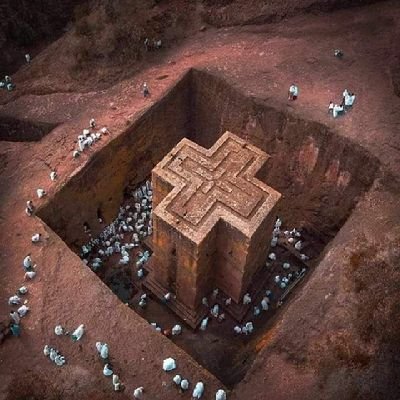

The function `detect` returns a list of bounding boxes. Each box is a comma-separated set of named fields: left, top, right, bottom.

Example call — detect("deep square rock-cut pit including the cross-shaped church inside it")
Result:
left=37, top=70, right=378, bottom=387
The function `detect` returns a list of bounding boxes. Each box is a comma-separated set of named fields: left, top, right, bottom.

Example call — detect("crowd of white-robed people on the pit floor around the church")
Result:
left=76, top=180, right=308, bottom=344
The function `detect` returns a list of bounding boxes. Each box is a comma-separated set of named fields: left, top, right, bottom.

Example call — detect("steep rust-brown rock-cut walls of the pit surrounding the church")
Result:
left=38, top=70, right=379, bottom=387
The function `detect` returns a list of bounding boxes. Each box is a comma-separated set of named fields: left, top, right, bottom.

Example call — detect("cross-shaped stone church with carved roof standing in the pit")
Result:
left=151, top=132, right=281, bottom=316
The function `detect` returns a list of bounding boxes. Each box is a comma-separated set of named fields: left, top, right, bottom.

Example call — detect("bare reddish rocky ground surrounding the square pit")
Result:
left=0, top=1, right=400, bottom=400
